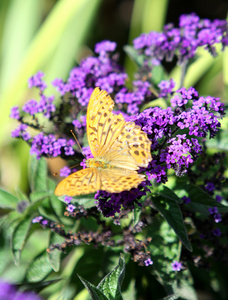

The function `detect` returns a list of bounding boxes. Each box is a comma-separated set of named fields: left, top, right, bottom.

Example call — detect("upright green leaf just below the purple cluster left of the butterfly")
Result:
left=29, top=155, right=47, bottom=191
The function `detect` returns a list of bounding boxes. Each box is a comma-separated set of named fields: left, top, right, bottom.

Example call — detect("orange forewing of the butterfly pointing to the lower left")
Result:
left=55, top=168, right=101, bottom=196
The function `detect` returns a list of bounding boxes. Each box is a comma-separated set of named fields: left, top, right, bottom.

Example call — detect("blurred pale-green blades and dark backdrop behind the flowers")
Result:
left=0, top=0, right=228, bottom=197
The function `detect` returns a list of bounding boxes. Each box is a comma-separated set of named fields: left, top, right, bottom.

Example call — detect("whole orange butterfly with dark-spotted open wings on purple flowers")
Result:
left=55, top=88, right=152, bottom=196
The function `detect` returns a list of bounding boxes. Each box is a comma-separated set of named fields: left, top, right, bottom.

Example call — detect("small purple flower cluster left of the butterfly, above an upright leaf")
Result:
left=30, top=132, right=75, bottom=159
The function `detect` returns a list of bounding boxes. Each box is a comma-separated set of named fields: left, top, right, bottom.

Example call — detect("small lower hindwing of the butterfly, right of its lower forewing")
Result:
left=99, top=169, right=145, bottom=193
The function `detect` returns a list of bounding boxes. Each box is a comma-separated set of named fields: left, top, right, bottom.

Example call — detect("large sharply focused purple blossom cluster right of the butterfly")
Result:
left=130, top=88, right=225, bottom=182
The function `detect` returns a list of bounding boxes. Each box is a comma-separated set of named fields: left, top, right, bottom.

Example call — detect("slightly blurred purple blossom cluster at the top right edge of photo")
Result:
left=133, top=14, right=228, bottom=65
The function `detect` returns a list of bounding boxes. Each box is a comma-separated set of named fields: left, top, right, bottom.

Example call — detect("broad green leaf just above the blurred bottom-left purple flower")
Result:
left=26, top=250, right=53, bottom=282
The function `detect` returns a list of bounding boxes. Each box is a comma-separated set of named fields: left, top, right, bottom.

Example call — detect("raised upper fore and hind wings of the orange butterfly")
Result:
left=87, top=88, right=152, bottom=170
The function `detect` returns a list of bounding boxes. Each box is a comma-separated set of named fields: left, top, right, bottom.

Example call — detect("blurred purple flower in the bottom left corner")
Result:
left=0, top=280, right=41, bottom=300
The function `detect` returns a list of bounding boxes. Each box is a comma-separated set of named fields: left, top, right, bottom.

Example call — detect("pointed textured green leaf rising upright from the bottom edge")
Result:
left=98, top=257, right=125, bottom=300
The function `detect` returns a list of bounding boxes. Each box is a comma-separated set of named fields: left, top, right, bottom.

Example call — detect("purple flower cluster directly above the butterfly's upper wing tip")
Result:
left=52, top=41, right=127, bottom=106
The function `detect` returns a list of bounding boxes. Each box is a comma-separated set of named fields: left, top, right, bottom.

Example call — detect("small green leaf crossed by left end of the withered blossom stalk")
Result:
left=47, top=232, right=64, bottom=272
